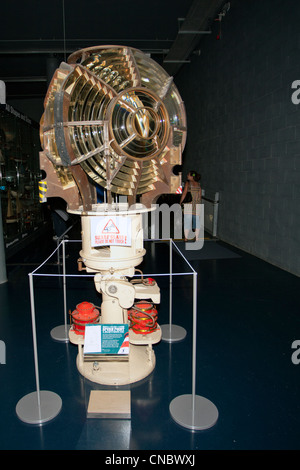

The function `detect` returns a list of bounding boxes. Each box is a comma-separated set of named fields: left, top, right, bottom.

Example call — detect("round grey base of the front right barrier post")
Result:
left=169, top=395, right=219, bottom=430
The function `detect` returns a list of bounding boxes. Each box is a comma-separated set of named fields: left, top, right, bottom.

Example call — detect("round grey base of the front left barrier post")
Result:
left=16, top=390, right=62, bottom=424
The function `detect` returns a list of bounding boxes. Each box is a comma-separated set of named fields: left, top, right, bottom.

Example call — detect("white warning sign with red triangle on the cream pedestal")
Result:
left=91, top=215, right=131, bottom=247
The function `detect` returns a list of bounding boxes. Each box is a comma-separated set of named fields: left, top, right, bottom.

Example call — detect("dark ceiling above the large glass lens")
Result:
left=0, top=0, right=225, bottom=100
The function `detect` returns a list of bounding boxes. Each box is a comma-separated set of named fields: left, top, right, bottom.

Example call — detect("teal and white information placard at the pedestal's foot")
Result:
left=83, top=323, right=129, bottom=356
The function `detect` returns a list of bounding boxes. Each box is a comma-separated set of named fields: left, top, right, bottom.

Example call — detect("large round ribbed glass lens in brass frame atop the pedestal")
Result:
left=40, top=46, right=186, bottom=207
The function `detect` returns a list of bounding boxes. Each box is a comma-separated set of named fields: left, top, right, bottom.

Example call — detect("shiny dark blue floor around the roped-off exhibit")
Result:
left=0, top=229, right=300, bottom=451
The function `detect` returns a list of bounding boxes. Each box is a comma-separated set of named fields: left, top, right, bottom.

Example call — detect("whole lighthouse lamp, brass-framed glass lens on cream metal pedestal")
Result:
left=40, top=46, right=186, bottom=385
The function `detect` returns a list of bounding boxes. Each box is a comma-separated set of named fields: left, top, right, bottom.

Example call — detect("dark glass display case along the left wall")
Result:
left=0, top=104, right=44, bottom=252
